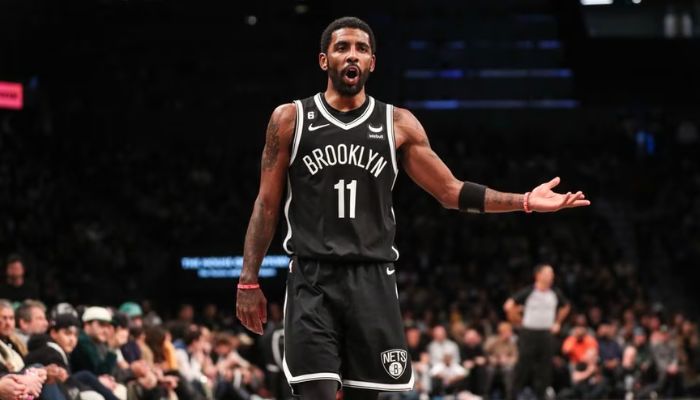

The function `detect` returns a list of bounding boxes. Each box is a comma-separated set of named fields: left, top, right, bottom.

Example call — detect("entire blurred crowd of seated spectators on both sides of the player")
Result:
left=0, top=256, right=700, bottom=400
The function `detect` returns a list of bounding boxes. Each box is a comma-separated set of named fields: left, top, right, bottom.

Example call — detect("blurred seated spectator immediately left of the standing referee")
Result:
left=484, top=322, right=518, bottom=398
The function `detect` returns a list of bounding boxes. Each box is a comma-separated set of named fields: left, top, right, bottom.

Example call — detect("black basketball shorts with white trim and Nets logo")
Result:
left=283, top=257, right=413, bottom=392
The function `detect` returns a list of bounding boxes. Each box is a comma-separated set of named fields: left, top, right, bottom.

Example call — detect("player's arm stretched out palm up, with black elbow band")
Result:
left=394, top=107, right=590, bottom=213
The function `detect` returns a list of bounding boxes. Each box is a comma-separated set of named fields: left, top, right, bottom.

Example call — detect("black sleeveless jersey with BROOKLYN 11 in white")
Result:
left=283, top=93, right=399, bottom=261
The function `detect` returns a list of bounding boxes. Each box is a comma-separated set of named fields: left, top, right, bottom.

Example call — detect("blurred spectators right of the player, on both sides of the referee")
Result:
left=406, top=296, right=700, bottom=399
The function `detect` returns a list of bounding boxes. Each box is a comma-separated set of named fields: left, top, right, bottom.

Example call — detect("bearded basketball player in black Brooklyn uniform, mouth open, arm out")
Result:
left=236, top=17, right=589, bottom=400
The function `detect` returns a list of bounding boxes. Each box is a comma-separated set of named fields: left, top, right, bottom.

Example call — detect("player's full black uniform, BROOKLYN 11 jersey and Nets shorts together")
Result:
left=283, top=93, right=413, bottom=391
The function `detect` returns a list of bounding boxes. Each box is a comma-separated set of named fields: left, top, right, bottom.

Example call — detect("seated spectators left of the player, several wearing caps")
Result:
left=0, top=257, right=288, bottom=400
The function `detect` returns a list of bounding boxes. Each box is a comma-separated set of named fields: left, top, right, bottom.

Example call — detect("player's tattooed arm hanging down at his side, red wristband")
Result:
left=236, top=104, right=296, bottom=335
